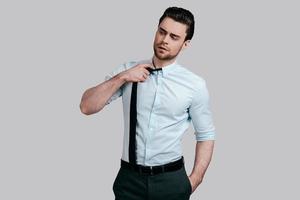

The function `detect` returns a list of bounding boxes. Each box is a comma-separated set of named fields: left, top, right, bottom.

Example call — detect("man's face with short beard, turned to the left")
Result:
left=153, top=17, right=190, bottom=61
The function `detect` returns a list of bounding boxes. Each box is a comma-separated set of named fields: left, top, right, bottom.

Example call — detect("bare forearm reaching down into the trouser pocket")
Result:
left=189, top=140, right=214, bottom=192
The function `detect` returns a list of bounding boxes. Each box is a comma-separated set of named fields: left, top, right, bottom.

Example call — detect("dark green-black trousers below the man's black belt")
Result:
left=113, top=162, right=192, bottom=200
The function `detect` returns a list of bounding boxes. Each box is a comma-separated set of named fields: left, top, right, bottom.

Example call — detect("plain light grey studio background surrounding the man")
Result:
left=0, top=0, right=300, bottom=200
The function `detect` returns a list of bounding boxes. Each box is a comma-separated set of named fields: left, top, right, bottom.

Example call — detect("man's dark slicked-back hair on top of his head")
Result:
left=159, top=7, right=195, bottom=41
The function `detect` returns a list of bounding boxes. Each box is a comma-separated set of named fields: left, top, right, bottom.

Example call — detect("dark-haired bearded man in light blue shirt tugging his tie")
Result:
left=80, top=7, right=215, bottom=200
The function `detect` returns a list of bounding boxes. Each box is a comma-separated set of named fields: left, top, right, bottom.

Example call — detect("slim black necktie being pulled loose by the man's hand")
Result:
left=129, top=67, right=162, bottom=165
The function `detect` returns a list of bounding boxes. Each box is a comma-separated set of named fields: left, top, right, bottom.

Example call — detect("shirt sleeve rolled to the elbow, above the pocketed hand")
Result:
left=189, top=80, right=215, bottom=141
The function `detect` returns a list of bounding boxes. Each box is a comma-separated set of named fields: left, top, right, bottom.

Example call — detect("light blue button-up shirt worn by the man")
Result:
left=105, top=59, right=215, bottom=166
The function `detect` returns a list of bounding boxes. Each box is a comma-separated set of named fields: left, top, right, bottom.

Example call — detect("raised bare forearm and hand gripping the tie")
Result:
left=80, top=64, right=151, bottom=115
